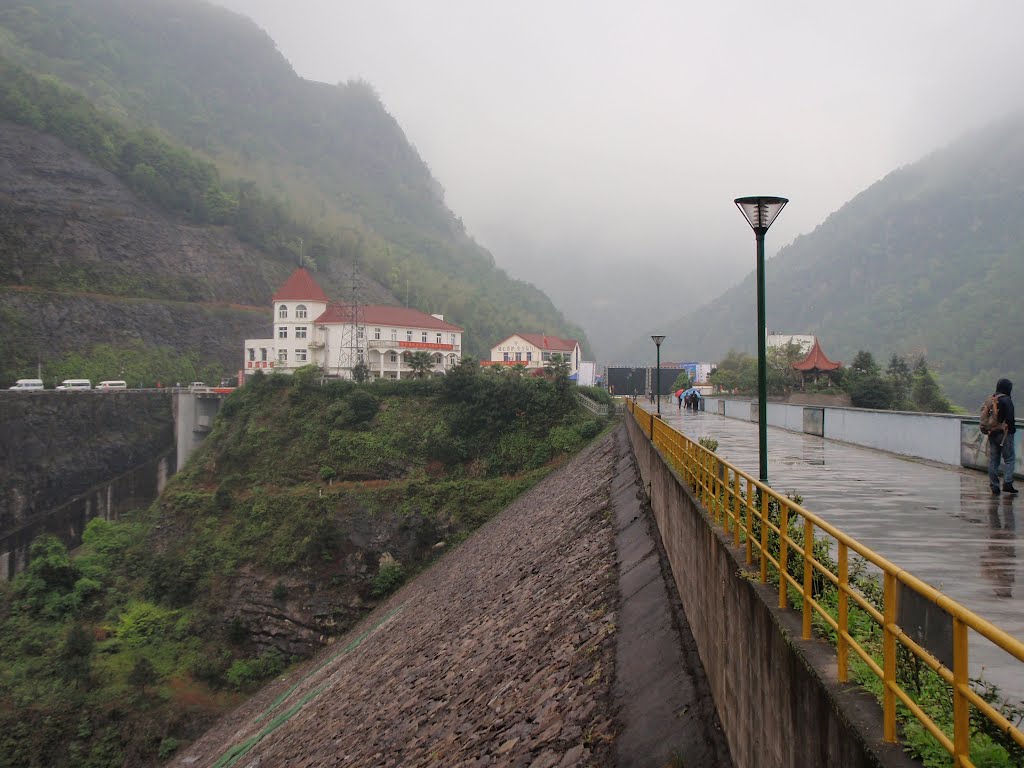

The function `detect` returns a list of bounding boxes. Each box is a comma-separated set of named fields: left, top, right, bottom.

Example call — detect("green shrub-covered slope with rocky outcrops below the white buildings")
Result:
left=0, top=366, right=602, bottom=766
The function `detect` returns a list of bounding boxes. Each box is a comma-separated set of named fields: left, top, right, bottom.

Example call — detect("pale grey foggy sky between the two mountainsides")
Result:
left=209, top=0, right=1024, bottom=360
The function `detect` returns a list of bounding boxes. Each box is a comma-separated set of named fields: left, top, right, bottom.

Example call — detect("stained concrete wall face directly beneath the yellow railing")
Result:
left=626, top=417, right=918, bottom=768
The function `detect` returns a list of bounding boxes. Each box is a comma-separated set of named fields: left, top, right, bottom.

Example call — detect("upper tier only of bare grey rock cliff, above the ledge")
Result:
left=0, top=122, right=294, bottom=306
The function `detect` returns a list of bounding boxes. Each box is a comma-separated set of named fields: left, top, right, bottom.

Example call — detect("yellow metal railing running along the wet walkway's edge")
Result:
left=627, top=401, right=1024, bottom=768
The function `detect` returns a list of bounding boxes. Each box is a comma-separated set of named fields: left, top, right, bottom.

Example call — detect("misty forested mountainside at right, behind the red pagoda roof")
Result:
left=662, top=114, right=1024, bottom=411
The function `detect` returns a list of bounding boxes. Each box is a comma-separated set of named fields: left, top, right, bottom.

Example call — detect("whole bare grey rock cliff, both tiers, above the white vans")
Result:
left=0, top=121, right=294, bottom=378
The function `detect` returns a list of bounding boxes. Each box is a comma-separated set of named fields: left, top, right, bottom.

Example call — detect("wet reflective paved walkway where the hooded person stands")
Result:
left=638, top=399, right=1024, bottom=700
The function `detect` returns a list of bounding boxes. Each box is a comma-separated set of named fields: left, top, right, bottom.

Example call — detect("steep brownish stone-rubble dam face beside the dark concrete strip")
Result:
left=174, top=438, right=617, bottom=768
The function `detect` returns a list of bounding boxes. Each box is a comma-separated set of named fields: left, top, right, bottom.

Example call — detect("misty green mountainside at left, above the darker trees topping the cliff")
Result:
left=0, top=0, right=583, bottom=356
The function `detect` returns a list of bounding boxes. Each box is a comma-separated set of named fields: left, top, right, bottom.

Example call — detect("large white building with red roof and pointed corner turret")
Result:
left=242, top=267, right=463, bottom=379
